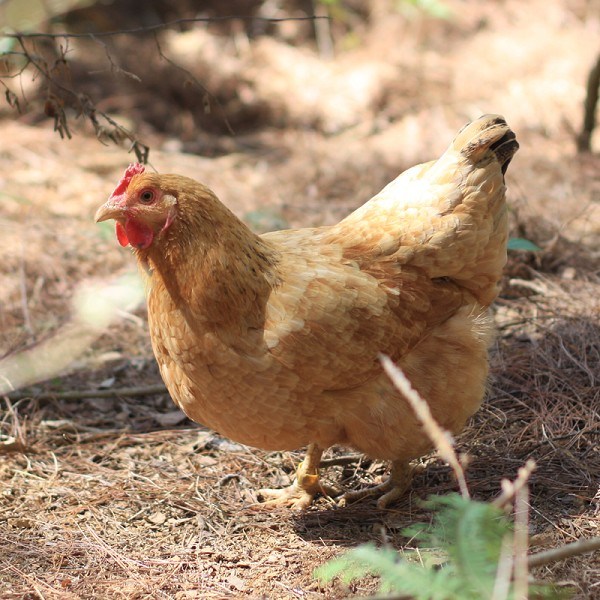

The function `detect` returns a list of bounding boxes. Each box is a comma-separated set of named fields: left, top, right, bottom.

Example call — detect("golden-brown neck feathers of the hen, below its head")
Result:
left=137, top=182, right=279, bottom=336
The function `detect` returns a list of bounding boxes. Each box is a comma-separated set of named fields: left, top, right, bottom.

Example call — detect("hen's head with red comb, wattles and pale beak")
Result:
left=96, top=163, right=218, bottom=250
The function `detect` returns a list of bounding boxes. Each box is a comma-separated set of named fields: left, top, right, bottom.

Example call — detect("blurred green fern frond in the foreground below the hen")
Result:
left=314, top=494, right=558, bottom=600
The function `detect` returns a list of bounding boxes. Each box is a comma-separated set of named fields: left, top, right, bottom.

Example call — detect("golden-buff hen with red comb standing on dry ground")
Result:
left=96, top=115, right=518, bottom=508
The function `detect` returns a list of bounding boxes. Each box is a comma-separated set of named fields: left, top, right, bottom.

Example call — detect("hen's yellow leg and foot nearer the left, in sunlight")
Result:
left=258, top=444, right=339, bottom=510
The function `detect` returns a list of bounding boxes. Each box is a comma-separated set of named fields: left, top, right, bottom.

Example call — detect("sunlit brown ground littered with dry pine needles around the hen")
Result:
left=0, top=0, right=600, bottom=600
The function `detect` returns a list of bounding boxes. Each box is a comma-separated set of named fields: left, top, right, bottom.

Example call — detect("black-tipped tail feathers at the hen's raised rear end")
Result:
left=451, top=115, right=519, bottom=174
